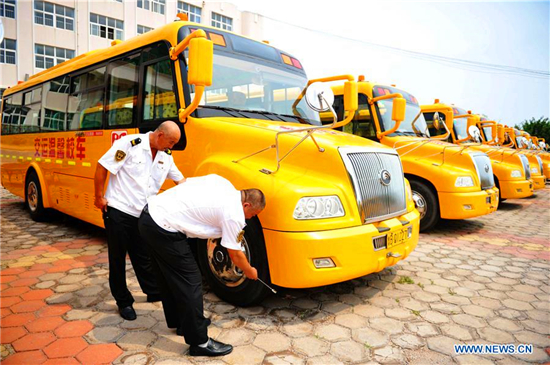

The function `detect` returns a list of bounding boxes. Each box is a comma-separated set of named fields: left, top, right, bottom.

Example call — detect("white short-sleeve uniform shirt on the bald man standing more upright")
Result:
left=99, top=132, right=183, bottom=217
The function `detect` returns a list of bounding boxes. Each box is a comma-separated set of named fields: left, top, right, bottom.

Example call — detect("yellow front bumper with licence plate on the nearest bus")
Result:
left=264, top=209, right=419, bottom=288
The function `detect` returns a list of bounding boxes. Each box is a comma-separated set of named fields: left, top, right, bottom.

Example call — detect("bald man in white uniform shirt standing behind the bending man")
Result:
left=94, top=121, right=185, bottom=321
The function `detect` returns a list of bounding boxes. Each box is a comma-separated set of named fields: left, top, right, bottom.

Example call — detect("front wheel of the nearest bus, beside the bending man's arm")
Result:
left=197, top=218, right=270, bottom=307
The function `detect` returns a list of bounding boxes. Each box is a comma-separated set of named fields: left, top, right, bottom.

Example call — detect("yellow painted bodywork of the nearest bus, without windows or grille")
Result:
left=0, top=21, right=419, bottom=287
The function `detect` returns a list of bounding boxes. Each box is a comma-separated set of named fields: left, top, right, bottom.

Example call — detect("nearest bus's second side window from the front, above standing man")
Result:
left=106, top=54, right=140, bottom=127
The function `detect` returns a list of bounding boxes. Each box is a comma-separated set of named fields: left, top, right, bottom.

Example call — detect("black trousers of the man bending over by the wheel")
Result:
left=139, top=206, right=208, bottom=346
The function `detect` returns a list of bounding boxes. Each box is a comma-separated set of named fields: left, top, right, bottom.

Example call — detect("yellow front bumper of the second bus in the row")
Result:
left=438, top=187, right=498, bottom=219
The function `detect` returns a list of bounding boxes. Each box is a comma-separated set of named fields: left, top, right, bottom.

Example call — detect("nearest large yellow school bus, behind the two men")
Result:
left=0, top=17, right=419, bottom=305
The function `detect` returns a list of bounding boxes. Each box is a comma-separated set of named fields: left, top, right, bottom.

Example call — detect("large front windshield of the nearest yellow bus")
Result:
left=185, top=27, right=321, bottom=125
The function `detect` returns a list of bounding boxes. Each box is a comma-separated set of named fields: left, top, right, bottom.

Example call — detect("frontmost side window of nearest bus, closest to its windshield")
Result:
left=143, top=59, right=178, bottom=121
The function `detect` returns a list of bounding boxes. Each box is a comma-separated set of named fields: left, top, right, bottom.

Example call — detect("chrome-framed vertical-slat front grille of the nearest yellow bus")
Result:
left=339, top=147, right=407, bottom=224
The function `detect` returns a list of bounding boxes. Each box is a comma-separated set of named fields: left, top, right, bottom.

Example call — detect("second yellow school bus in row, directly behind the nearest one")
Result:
left=333, top=82, right=498, bottom=231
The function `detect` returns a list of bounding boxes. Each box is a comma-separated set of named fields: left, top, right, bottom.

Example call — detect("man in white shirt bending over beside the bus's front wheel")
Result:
left=139, top=175, right=265, bottom=356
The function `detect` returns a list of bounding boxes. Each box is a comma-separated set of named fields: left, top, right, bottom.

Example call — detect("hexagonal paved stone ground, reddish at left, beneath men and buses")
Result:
left=0, top=187, right=550, bottom=365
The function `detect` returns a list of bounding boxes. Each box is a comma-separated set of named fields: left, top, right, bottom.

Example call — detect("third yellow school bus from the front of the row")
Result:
left=422, top=99, right=533, bottom=201
